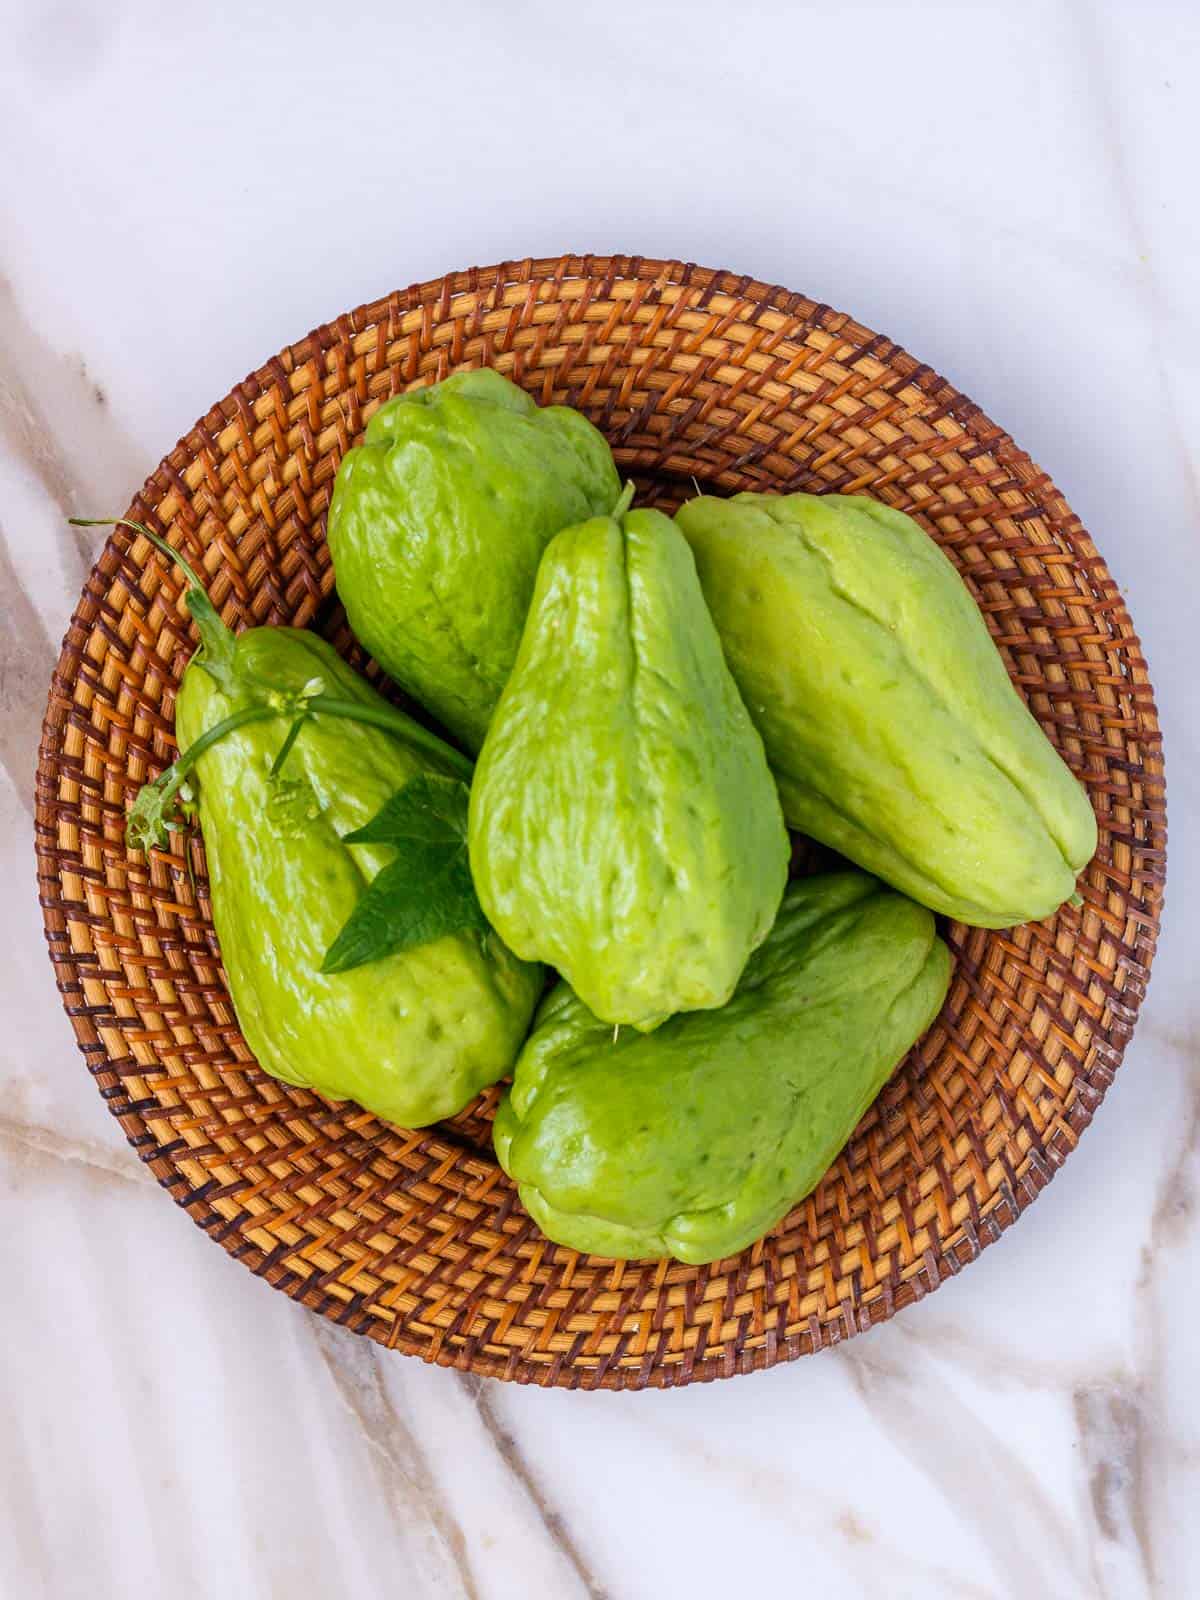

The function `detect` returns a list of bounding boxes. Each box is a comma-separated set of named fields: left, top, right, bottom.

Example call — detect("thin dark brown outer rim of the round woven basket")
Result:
left=34, top=254, right=1166, bottom=1392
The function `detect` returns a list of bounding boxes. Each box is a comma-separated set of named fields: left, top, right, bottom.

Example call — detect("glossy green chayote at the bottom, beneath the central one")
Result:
left=494, top=872, right=950, bottom=1264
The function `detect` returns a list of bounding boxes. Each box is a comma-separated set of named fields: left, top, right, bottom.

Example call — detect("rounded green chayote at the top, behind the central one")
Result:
left=328, top=368, right=621, bottom=750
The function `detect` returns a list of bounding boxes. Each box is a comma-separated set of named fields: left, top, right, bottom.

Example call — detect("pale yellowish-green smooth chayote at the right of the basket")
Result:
left=675, top=494, right=1096, bottom=928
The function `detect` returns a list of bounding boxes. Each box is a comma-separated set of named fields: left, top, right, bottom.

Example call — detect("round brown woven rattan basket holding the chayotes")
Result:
left=37, top=256, right=1165, bottom=1389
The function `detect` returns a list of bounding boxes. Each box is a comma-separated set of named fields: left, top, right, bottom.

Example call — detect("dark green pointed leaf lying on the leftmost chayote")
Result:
left=322, top=776, right=488, bottom=973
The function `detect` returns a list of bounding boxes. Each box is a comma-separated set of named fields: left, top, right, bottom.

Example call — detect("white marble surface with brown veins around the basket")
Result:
left=0, top=0, right=1200, bottom=1600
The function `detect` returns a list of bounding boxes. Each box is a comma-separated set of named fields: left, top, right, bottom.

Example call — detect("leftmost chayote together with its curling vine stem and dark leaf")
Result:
left=102, top=523, right=541, bottom=1126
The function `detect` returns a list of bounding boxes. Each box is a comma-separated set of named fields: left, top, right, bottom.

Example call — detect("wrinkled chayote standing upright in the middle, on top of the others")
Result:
left=469, top=491, right=789, bottom=1029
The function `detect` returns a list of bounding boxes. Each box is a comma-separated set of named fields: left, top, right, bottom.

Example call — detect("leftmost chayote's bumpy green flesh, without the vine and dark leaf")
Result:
left=176, top=624, right=541, bottom=1126
